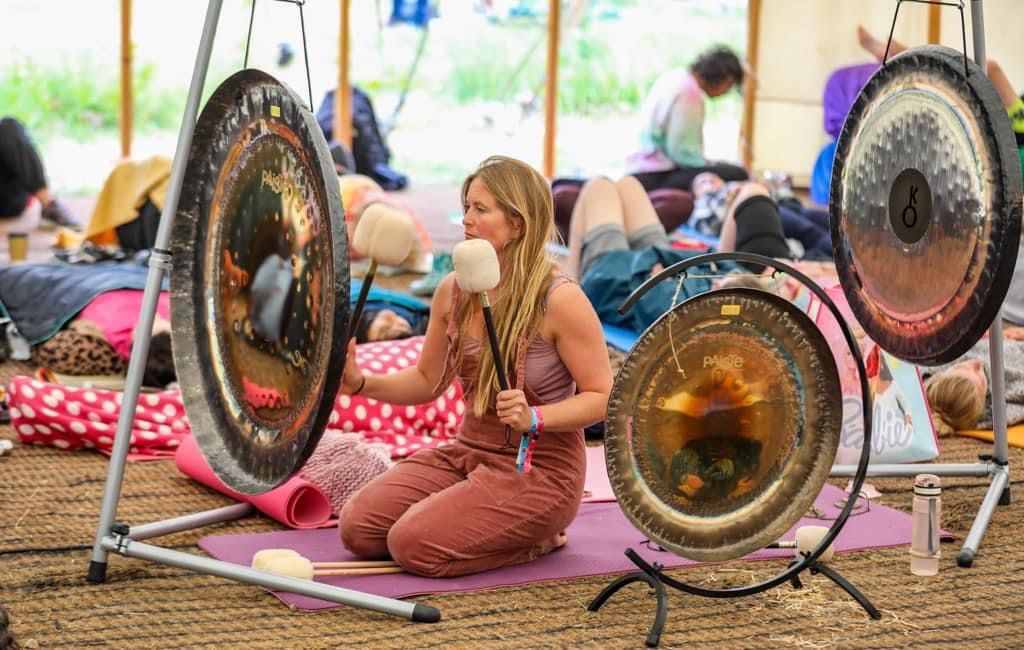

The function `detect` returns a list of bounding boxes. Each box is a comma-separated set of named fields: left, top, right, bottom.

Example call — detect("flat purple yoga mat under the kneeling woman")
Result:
left=199, top=484, right=945, bottom=609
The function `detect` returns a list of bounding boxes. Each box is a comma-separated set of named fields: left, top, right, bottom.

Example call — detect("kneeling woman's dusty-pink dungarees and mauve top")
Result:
left=339, top=275, right=586, bottom=577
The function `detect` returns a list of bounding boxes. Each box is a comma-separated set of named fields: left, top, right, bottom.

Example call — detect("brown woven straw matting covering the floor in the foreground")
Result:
left=0, top=354, right=1024, bottom=648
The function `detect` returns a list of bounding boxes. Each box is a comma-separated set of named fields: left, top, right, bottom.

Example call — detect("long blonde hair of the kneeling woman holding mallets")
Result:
left=456, top=156, right=557, bottom=416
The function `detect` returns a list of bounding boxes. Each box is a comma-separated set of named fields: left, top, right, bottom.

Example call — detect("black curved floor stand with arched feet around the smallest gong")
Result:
left=587, top=252, right=882, bottom=648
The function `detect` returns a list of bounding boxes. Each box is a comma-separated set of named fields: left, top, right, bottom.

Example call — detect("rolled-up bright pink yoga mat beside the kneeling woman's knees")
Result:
left=174, top=436, right=338, bottom=528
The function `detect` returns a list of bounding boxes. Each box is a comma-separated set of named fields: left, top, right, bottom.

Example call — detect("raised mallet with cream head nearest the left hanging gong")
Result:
left=348, top=203, right=416, bottom=339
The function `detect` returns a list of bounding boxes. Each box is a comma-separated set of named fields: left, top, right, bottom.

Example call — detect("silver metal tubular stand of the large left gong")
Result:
left=87, top=0, right=440, bottom=622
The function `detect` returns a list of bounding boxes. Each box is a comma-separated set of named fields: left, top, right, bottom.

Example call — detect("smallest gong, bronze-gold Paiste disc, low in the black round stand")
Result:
left=604, top=289, right=843, bottom=561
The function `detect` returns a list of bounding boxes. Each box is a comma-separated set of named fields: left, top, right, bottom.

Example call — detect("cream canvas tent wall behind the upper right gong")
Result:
left=744, top=0, right=1024, bottom=186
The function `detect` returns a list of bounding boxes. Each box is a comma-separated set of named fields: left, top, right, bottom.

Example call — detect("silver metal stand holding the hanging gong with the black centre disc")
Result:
left=831, top=0, right=1020, bottom=567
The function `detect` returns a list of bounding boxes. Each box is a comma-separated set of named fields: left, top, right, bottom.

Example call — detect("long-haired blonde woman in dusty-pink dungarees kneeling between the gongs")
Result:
left=339, top=157, right=611, bottom=576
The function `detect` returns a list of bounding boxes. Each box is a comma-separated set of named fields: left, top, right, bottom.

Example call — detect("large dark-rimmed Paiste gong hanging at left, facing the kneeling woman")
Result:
left=171, top=70, right=349, bottom=494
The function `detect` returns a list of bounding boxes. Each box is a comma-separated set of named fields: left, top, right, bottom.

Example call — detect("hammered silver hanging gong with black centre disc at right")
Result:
left=829, top=46, right=1021, bottom=364
